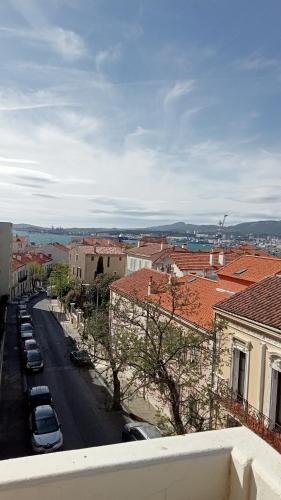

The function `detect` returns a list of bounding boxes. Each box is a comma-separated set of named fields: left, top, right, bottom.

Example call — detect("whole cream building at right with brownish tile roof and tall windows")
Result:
left=214, top=276, right=281, bottom=452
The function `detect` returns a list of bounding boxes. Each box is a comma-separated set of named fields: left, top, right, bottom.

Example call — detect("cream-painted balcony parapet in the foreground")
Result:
left=0, top=427, right=281, bottom=500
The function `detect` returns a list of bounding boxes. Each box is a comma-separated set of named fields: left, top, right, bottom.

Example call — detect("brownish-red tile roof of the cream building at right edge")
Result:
left=215, top=276, right=281, bottom=330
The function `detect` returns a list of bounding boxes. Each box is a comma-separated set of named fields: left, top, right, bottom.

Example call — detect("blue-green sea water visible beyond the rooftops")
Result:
left=14, top=231, right=212, bottom=252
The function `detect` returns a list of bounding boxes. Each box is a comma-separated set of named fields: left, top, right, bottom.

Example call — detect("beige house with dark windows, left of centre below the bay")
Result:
left=69, top=245, right=127, bottom=283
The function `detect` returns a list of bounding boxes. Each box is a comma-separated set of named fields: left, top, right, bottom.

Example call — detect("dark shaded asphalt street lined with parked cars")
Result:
left=0, top=299, right=124, bottom=458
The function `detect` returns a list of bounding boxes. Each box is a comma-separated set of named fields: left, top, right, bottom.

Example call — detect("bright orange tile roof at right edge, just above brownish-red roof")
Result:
left=217, top=255, right=281, bottom=284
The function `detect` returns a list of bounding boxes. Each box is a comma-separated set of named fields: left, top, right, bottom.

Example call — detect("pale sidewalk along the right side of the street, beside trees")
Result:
left=49, top=299, right=158, bottom=424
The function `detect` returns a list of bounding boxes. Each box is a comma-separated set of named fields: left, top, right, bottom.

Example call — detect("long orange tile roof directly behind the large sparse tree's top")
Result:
left=111, top=269, right=245, bottom=329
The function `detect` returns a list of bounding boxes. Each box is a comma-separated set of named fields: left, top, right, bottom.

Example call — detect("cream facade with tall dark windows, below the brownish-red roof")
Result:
left=216, top=311, right=281, bottom=440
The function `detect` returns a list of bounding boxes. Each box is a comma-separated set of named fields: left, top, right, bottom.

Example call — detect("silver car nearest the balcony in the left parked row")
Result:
left=30, top=405, right=63, bottom=453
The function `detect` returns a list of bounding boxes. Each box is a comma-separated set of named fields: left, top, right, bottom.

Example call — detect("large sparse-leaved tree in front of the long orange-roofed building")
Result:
left=109, top=280, right=228, bottom=434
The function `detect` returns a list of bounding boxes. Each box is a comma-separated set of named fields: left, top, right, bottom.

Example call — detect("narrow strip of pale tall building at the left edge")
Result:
left=0, top=222, right=12, bottom=298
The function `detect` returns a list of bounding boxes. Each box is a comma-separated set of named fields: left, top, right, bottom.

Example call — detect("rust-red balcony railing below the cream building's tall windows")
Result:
left=218, top=380, right=281, bottom=453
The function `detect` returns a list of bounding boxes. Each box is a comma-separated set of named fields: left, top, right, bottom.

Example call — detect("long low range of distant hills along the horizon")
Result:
left=13, top=220, right=281, bottom=236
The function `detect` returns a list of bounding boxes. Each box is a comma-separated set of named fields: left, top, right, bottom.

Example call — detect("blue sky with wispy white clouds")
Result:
left=0, top=0, right=281, bottom=228
